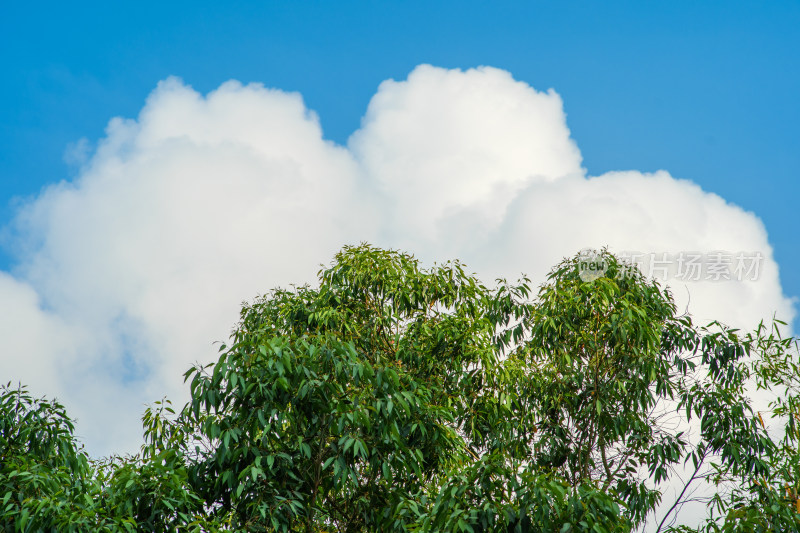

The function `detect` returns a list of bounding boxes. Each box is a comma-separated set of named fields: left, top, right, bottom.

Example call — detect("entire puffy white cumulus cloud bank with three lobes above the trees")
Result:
left=0, top=66, right=792, bottom=453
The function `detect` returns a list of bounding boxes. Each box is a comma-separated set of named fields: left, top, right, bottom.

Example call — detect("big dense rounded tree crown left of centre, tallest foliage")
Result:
left=178, top=247, right=506, bottom=531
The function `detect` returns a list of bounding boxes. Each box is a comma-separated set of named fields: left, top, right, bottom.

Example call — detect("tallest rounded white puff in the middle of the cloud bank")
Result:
left=349, top=65, right=583, bottom=254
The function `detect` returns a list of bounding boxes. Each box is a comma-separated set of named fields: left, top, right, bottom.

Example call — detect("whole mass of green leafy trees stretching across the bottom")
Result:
left=0, top=245, right=800, bottom=533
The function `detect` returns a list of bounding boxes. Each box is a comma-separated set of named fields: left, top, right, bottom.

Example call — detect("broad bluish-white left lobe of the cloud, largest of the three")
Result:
left=0, top=79, right=374, bottom=452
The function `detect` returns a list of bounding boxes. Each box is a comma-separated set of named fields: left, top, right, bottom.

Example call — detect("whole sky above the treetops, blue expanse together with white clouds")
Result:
left=0, top=0, right=800, bottom=466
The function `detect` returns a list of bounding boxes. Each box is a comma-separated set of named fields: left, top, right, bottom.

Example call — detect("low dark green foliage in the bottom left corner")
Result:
left=0, top=385, right=212, bottom=532
